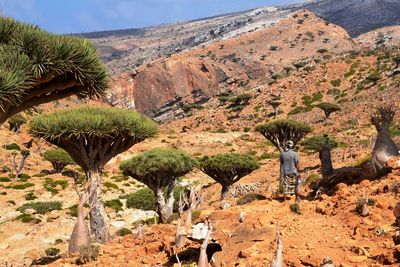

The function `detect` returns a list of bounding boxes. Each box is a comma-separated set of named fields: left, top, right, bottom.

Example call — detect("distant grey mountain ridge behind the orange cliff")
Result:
left=78, top=0, right=400, bottom=75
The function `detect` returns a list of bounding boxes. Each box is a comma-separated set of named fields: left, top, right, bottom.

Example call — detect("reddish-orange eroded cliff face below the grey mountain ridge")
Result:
left=108, top=10, right=356, bottom=121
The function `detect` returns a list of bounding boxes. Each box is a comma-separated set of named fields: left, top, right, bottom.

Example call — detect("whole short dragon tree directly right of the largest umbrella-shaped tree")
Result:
left=120, top=148, right=195, bottom=223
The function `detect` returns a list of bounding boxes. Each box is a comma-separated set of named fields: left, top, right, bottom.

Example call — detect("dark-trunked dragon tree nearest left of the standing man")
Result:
left=198, top=153, right=260, bottom=199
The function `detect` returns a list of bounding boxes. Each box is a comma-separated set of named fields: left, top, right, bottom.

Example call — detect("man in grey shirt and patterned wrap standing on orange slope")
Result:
left=279, top=141, right=301, bottom=202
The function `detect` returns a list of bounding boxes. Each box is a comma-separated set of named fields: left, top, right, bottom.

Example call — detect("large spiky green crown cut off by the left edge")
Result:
left=0, top=17, right=108, bottom=123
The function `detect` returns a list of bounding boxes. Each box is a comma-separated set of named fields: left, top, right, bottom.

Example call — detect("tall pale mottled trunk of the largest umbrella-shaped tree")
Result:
left=88, top=171, right=111, bottom=243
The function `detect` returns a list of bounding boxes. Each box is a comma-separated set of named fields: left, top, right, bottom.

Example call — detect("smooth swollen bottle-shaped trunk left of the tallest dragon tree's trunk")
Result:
left=68, top=196, right=91, bottom=253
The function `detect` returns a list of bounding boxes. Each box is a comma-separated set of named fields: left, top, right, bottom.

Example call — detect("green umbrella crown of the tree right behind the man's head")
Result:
left=255, top=119, right=311, bottom=149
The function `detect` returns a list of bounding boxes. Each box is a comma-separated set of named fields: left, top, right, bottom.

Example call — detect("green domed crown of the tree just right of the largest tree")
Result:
left=120, top=148, right=195, bottom=191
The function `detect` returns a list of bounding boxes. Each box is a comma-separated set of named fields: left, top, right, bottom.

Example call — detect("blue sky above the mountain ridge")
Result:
left=0, top=0, right=302, bottom=33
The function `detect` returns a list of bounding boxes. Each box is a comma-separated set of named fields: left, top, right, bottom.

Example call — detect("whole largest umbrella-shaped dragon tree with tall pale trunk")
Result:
left=30, top=107, right=156, bottom=243
